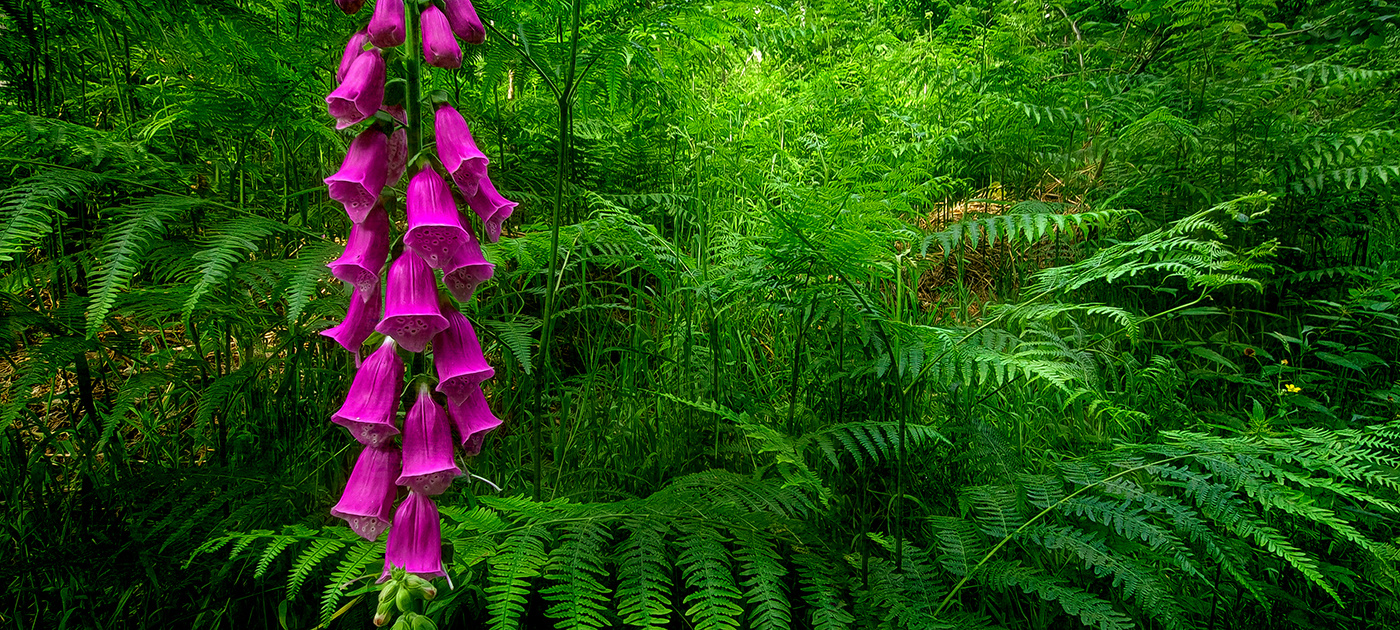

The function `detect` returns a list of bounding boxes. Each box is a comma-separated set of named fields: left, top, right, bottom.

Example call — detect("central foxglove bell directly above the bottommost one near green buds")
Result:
left=395, top=384, right=462, bottom=496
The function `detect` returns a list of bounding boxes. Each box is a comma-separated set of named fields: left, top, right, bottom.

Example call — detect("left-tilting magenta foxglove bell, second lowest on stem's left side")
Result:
left=330, top=339, right=403, bottom=447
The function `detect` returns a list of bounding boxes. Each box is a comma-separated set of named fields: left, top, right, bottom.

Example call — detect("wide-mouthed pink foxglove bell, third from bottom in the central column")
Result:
left=375, top=252, right=447, bottom=353
